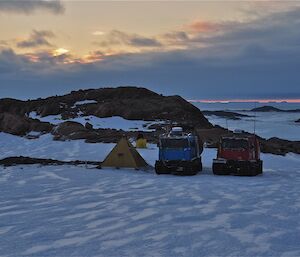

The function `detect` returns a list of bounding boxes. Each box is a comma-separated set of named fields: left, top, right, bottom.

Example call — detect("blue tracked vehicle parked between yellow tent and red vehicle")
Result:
left=155, top=127, right=203, bottom=175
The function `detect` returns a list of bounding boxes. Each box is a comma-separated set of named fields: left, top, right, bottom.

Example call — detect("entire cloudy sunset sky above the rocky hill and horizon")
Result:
left=0, top=0, right=300, bottom=100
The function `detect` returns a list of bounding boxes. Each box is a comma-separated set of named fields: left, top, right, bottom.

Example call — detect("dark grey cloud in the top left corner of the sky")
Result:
left=0, top=0, right=65, bottom=15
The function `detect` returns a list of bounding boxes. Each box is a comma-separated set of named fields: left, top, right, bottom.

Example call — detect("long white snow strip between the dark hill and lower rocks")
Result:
left=29, top=112, right=159, bottom=131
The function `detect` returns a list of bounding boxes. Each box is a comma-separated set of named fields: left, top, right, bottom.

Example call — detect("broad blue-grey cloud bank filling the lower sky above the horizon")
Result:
left=0, top=8, right=300, bottom=99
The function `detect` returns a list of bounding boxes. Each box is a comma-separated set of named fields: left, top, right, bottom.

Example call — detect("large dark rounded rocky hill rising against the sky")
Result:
left=0, top=87, right=212, bottom=128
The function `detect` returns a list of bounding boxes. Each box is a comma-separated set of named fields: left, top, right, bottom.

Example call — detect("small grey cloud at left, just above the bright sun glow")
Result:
left=17, top=30, right=55, bottom=48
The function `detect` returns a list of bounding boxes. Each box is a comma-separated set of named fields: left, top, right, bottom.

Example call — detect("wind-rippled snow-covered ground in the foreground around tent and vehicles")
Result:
left=0, top=133, right=300, bottom=256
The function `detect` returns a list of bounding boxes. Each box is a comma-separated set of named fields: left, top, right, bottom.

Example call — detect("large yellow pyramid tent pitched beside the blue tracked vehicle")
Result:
left=101, top=137, right=148, bottom=169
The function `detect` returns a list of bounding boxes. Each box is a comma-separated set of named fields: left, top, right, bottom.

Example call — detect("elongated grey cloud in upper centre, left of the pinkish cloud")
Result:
left=97, top=30, right=161, bottom=47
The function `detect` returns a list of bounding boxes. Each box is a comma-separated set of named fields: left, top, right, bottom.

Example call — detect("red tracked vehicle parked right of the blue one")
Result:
left=213, top=131, right=263, bottom=176
